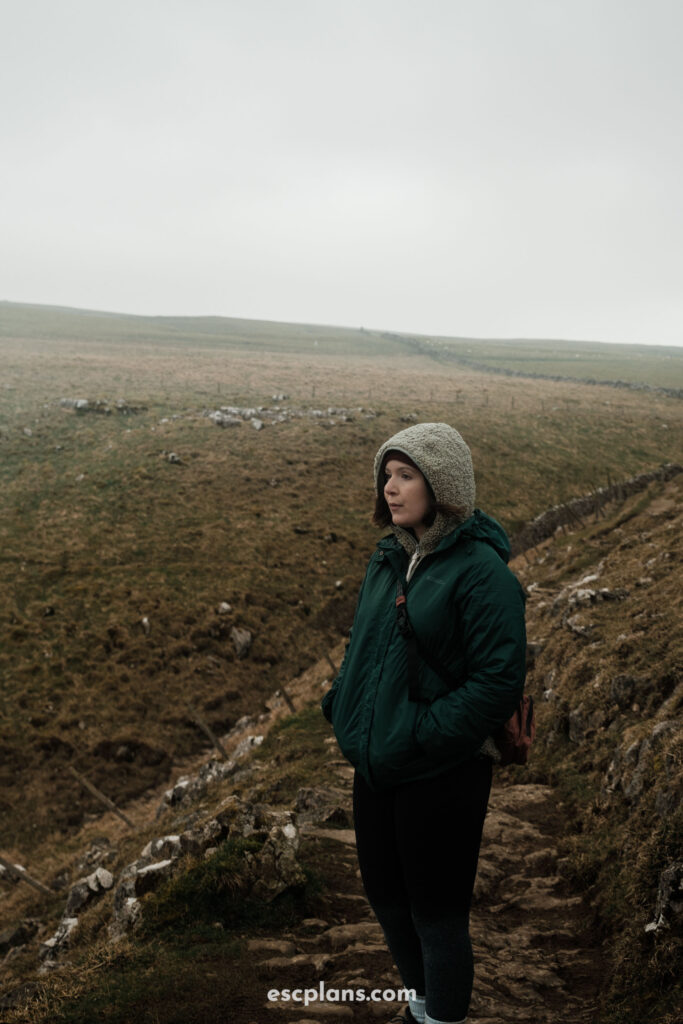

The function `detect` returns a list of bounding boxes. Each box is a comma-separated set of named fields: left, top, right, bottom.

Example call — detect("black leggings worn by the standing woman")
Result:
left=353, top=757, right=492, bottom=1021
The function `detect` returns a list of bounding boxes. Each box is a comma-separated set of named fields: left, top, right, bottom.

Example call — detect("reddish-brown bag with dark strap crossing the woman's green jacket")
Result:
left=396, top=580, right=536, bottom=765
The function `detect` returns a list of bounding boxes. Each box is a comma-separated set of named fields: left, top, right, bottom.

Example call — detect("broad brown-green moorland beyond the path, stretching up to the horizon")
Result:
left=0, top=304, right=683, bottom=859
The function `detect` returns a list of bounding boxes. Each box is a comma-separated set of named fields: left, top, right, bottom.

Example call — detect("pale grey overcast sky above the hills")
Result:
left=0, top=0, right=683, bottom=345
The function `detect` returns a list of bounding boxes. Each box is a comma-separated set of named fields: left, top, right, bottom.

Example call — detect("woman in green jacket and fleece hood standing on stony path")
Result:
left=323, top=423, right=526, bottom=1024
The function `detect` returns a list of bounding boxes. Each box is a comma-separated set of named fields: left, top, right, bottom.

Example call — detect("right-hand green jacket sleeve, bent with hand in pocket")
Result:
left=417, top=561, right=526, bottom=762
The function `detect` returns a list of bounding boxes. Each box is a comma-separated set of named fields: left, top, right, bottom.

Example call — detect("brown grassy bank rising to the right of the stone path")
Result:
left=516, top=475, right=683, bottom=1022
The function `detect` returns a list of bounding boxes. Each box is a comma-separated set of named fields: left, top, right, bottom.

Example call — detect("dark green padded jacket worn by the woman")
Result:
left=322, top=509, right=526, bottom=790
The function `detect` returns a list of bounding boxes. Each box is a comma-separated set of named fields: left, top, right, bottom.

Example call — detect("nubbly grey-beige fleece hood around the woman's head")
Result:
left=375, top=423, right=475, bottom=553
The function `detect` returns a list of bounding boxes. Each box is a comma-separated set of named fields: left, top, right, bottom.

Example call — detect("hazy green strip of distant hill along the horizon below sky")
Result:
left=0, top=302, right=683, bottom=388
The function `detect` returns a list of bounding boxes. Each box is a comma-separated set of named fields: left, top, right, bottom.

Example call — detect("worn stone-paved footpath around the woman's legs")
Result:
left=250, top=761, right=600, bottom=1024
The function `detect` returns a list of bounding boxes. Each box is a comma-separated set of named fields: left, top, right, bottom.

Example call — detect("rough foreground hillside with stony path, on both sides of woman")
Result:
left=0, top=475, right=683, bottom=1024
